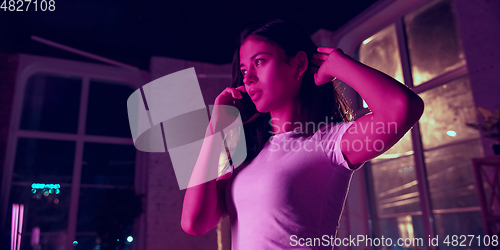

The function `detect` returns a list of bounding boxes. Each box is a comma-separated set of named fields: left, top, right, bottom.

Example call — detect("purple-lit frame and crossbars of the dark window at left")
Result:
left=0, top=54, right=150, bottom=249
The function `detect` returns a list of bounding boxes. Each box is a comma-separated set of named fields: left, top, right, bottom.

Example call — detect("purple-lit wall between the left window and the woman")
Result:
left=144, top=57, right=231, bottom=250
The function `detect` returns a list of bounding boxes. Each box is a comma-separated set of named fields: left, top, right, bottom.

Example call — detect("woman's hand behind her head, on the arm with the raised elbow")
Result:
left=312, top=47, right=349, bottom=86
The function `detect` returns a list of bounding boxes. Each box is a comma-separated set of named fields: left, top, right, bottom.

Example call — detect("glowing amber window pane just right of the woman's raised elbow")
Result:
left=419, top=77, right=479, bottom=149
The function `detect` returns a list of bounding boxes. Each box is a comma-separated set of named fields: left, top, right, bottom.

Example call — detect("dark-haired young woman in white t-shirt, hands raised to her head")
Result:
left=181, top=20, right=424, bottom=249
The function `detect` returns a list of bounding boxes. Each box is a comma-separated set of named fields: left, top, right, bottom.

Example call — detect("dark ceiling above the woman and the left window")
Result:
left=0, top=0, right=376, bottom=70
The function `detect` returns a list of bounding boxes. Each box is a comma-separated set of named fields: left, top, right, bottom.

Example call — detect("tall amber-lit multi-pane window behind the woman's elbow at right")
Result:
left=358, top=0, right=484, bottom=249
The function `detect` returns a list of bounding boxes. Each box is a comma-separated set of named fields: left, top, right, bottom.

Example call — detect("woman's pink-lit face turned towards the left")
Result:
left=240, top=38, right=300, bottom=113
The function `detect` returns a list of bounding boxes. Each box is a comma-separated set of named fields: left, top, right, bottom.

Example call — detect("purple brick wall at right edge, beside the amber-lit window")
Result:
left=453, top=0, right=500, bottom=156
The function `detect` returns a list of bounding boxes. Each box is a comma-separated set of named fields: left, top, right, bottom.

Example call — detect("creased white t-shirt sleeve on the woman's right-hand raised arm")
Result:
left=320, top=122, right=363, bottom=171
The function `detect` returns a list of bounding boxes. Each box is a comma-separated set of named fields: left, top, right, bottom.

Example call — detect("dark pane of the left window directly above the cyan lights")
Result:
left=13, top=138, right=75, bottom=183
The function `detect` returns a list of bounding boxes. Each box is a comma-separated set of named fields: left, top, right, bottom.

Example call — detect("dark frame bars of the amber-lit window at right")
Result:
left=328, top=0, right=470, bottom=244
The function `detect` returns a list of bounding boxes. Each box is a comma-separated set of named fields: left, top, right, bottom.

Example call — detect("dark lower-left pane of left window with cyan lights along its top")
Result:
left=7, top=185, right=71, bottom=233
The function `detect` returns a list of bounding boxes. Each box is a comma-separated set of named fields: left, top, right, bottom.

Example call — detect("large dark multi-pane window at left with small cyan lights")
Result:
left=2, top=55, right=147, bottom=249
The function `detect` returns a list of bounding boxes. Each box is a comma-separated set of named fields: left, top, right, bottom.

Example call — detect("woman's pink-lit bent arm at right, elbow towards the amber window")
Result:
left=313, top=47, right=424, bottom=169
